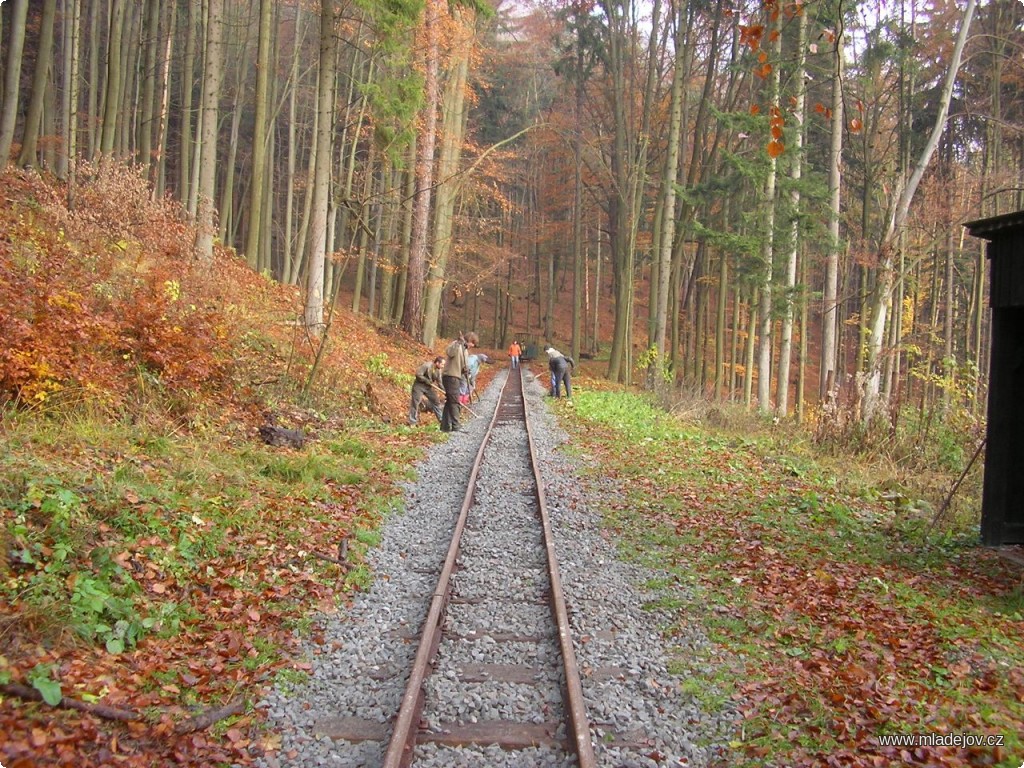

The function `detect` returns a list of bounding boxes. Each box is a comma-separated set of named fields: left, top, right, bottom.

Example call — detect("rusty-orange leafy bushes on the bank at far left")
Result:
left=0, top=164, right=231, bottom=407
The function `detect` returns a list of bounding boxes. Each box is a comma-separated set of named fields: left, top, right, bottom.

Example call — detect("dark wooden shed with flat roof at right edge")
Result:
left=964, top=211, right=1024, bottom=547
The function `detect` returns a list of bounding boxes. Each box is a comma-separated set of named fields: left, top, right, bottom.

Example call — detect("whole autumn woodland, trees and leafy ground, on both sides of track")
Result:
left=0, top=0, right=1024, bottom=768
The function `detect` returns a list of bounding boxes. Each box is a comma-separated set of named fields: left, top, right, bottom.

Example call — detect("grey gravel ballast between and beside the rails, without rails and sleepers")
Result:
left=258, top=370, right=733, bottom=768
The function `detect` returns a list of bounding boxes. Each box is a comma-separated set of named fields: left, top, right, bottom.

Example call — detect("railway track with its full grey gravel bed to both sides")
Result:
left=256, top=368, right=737, bottom=768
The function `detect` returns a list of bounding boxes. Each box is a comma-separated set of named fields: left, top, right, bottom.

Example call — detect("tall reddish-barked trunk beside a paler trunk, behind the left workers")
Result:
left=401, top=0, right=440, bottom=339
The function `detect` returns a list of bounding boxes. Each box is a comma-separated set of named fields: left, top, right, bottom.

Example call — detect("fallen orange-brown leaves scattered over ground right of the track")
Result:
left=587, top=425, right=1024, bottom=768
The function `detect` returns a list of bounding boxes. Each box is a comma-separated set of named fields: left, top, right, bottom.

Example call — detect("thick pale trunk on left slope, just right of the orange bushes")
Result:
left=196, top=0, right=224, bottom=261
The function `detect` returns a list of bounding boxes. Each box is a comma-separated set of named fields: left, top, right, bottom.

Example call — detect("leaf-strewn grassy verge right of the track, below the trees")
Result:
left=564, top=389, right=1024, bottom=768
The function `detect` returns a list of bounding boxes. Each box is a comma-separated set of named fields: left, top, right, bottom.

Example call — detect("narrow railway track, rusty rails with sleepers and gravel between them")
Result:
left=383, top=370, right=595, bottom=768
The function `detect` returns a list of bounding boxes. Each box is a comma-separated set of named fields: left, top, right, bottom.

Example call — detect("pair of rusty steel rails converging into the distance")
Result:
left=383, top=368, right=596, bottom=768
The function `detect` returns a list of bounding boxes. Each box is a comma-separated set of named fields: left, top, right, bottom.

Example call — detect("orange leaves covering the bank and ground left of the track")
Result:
left=0, top=163, right=433, bottom=768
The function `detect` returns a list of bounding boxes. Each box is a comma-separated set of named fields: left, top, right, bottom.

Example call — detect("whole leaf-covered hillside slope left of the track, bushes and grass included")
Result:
left=0, top=166, right=456, bottom=768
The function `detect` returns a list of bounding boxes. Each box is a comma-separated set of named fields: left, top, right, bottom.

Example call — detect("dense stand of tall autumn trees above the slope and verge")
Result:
left=0, top=0, right=1024, bottom=422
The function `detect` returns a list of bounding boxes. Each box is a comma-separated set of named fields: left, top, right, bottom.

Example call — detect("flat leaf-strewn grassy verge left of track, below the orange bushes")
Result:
left=0, top=412, right=423, bottom=764
